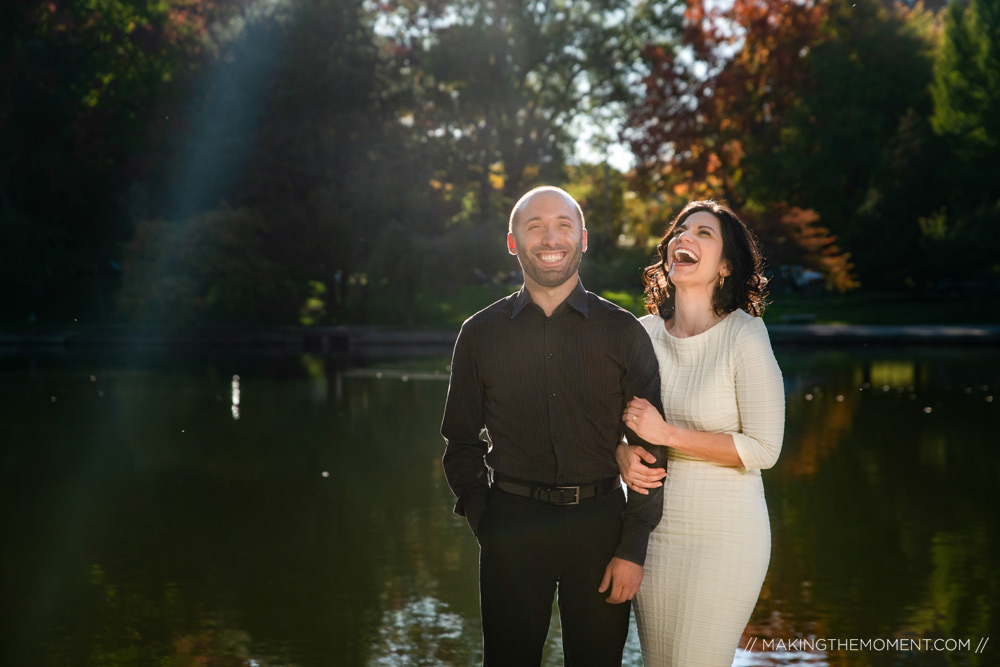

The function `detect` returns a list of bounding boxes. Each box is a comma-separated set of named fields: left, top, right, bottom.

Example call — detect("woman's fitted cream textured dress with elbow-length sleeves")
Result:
left=635, top=310, right=785, bottom=667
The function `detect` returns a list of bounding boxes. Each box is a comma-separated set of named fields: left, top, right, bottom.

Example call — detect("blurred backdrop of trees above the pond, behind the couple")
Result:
left=0, top=0, right=1000, bottom=330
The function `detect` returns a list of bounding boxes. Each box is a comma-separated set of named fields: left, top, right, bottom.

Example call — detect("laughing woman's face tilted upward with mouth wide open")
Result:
left=666, top=211, right=731, bottom=286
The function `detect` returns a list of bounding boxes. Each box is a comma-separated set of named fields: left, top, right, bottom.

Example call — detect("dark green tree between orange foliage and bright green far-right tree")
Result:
left=744, top=0, right=933, bottom=240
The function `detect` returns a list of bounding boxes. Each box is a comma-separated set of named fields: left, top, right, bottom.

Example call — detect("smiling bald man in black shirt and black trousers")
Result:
left=441, top=187, right=666, bottom=667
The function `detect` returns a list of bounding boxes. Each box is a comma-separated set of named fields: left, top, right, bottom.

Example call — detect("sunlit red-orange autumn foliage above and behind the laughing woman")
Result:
left=629, top=0, right=857, bottom=291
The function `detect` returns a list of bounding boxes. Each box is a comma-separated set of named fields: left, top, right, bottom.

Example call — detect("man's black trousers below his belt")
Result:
left=478, top=488, right=631, bottom=667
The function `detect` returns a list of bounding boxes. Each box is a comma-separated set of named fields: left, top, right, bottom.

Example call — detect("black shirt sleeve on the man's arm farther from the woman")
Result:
left=441, top=322, right=489, bottom=533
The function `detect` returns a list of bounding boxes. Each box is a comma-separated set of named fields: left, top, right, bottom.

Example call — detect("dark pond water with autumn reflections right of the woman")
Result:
left=745, top=350, right=1000, bottom=665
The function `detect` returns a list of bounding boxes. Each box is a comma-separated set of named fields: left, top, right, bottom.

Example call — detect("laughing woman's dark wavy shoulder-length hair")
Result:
left=642, top=200, right=767, bottom=320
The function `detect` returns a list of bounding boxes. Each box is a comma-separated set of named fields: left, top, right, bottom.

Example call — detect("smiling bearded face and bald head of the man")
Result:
left=507, top=192, right=587, bottom=288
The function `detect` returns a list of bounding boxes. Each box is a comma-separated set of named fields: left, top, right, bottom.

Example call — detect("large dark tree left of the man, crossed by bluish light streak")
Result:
left=142, top=0, right=434, bottom=323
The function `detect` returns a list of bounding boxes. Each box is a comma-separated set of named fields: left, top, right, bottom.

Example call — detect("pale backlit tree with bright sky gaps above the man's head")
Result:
left=382, top=0, right=675, bottom=235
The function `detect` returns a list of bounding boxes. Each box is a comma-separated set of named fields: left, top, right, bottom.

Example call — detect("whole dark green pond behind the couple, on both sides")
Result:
left=0, top=346, right=1000, bottom=667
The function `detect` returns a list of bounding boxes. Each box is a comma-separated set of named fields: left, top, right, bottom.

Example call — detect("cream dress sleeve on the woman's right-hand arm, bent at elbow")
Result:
left=730, top=317, right=785, bottom=470
